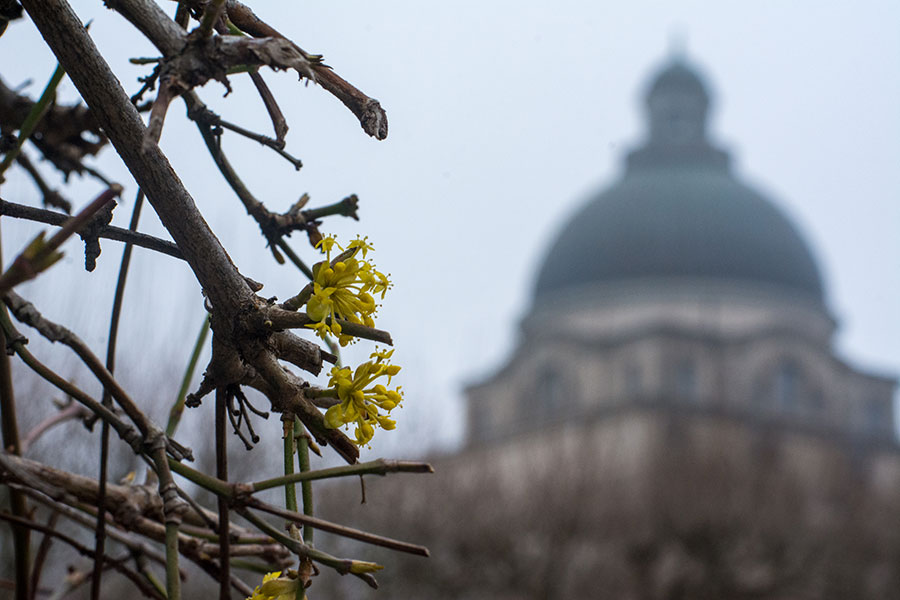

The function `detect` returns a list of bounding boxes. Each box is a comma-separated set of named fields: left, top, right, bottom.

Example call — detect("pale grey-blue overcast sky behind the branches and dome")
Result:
left=0, top=0, right=900, bottom=452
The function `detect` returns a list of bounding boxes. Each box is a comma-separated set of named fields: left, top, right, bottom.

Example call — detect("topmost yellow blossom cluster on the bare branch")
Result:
left=306, top=236, right=391, bottom=346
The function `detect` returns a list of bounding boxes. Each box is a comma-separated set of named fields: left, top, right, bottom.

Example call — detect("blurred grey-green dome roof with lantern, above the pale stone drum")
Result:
left=535, top=60, right=824, bottom=304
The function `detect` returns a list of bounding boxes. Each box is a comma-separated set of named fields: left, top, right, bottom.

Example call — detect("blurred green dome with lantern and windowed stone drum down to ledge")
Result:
left=467, top=58, right=896, bottom=444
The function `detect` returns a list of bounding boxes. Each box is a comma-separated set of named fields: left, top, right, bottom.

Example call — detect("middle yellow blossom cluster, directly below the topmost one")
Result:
left=325, top=350, right=403, bottom=446
